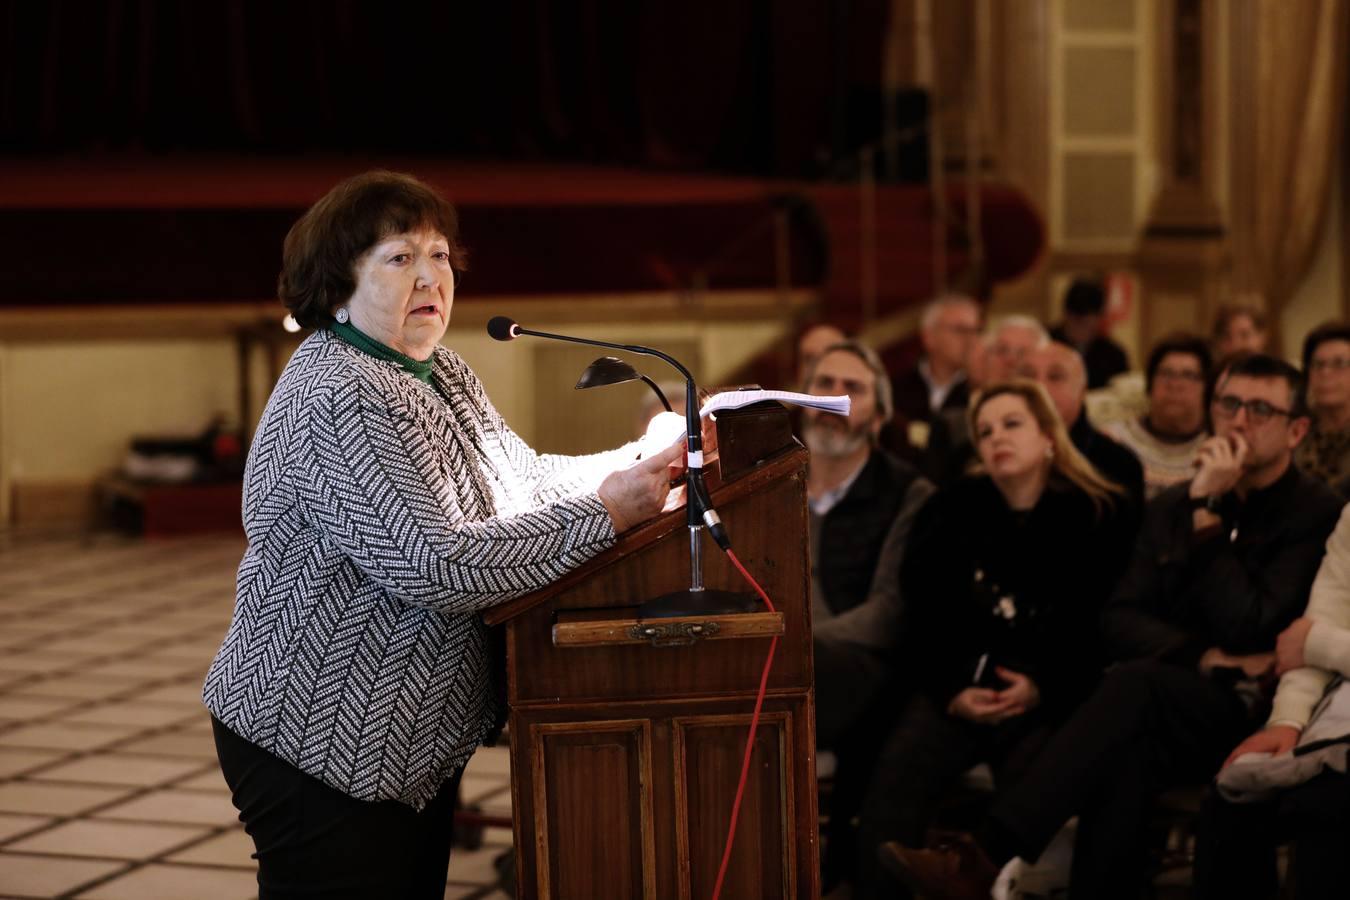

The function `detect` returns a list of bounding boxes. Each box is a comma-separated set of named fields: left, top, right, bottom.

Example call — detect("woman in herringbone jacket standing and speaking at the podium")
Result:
left=203, top=171, right=683, bottom=900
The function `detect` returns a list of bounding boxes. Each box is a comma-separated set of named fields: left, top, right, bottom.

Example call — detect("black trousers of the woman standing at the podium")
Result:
left=212, top=718, right=459, bottom=900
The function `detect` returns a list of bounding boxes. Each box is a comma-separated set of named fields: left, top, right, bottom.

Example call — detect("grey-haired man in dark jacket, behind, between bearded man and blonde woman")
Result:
left=891, top=294, right=980, bottom=451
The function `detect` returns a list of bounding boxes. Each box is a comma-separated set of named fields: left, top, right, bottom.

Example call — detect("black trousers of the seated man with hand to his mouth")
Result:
left=977, top=660, right=1254, bottom=900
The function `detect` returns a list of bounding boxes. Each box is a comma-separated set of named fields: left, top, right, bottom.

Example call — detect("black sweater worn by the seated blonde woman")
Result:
left=902, top=476, right=1130, bottom=715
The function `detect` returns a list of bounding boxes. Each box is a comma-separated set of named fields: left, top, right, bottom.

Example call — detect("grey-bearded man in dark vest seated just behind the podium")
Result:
left=802, top=341, right=933, bottom=881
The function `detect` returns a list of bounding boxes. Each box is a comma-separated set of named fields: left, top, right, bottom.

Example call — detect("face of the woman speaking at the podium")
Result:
left=347, top=231, right=455, bottom=359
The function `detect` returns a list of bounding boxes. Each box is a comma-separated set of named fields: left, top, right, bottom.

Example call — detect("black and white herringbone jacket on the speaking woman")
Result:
left=203, top=332, right=620, bottom=808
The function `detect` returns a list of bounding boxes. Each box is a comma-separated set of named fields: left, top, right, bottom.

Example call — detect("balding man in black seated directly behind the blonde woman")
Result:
left=1019, top=341, right=1143, bottom=520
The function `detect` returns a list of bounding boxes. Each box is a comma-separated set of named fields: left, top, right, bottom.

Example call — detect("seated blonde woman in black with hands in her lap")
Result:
left=859, top=379, right=1129, bottom=896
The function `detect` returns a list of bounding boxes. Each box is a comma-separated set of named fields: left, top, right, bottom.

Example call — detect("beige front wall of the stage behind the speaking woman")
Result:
left=0, top=300, right=788, bottom=525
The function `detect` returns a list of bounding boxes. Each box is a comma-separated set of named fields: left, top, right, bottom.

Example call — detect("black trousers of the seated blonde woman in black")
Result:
left=855, top=694, right=1050, bottom=897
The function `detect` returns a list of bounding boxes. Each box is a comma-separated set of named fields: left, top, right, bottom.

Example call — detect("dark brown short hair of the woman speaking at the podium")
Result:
left=277, top=170, right=467, bottom=328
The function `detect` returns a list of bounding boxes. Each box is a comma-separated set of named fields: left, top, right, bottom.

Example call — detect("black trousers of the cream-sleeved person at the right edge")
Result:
left=1195, top=772, right=1350, bottom=900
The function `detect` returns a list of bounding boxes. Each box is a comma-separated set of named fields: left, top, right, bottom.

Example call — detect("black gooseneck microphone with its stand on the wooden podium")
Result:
left=487, top=316, right=753, bottom=618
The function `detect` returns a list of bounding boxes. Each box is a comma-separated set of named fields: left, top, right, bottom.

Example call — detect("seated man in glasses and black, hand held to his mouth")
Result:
left=883, top=356, right=1341, bottom=900
